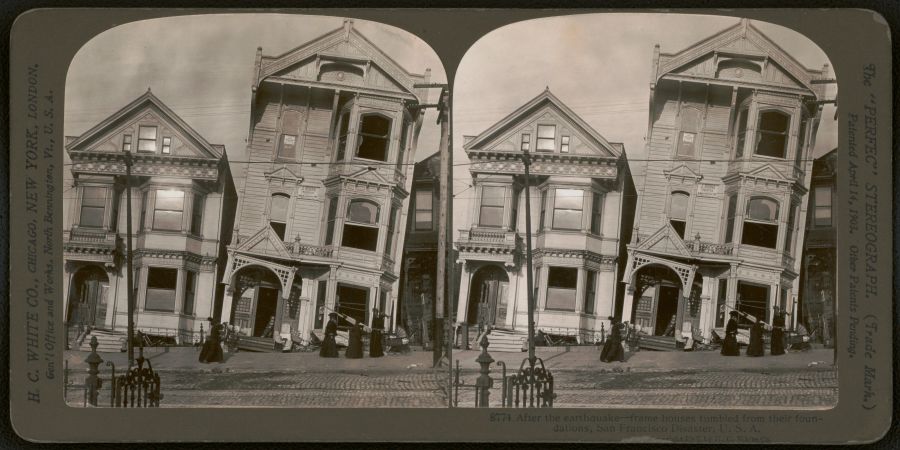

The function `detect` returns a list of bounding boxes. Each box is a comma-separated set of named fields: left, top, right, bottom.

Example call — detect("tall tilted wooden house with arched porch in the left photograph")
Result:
left=219, top=20, right=430, bottom=349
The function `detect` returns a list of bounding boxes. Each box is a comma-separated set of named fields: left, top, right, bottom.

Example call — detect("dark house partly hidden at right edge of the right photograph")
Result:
left=796, top=149, right=837, bottom=347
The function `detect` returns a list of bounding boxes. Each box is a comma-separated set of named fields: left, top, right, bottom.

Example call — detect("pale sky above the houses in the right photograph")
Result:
left=453, top=13, right=837, bottom=239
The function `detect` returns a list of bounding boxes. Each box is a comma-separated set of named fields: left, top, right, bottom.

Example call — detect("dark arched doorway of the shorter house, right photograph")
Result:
left=466, top=264, right=509, bottom=326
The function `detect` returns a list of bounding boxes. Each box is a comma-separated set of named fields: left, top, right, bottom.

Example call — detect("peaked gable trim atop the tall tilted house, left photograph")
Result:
left=254, top=19, right=430, bottom=102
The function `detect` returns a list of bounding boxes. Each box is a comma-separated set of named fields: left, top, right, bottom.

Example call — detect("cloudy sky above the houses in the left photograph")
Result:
left=65, top=14, right=446, bottom=178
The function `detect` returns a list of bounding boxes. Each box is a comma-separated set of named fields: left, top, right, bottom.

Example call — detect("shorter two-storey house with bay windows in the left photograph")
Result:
left=63, top=89, right=237, bottom=342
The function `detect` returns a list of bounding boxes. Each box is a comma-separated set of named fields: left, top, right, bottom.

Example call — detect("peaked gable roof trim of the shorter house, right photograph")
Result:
left=463, top=88, right=622, bottom=158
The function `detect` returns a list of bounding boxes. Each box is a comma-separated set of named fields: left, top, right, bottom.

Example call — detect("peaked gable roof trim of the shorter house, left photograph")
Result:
left=66, top=89, right=225, bottom=159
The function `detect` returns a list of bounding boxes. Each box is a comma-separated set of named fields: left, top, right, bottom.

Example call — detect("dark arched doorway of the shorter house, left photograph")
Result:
left=66, top=264, right=109, bottom=328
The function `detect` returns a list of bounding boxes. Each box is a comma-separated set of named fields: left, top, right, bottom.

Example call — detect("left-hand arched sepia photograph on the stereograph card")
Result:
left=63, top=14, right=446, bottom=407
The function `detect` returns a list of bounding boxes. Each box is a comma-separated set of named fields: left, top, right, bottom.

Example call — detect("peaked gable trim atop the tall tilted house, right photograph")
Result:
left=653, top=19, right=827, bottom=96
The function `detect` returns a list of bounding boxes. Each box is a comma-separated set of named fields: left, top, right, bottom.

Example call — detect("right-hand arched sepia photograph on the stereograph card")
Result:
left=450, top=13, right=841, bottom=409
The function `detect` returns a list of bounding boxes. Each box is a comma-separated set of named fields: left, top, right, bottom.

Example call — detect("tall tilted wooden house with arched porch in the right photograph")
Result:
left=621, top=20, right=828, bottom=348
